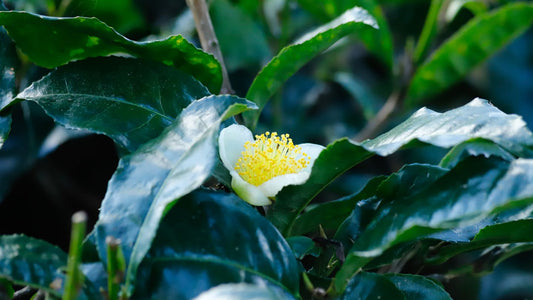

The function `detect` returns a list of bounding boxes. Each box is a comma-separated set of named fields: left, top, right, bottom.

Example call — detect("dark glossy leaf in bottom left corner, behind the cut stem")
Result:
left=0, top=235, right=101, bottom=299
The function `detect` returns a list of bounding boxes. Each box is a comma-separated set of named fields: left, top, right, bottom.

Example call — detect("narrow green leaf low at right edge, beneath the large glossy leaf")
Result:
left=427, top=219, right=533, bottom=264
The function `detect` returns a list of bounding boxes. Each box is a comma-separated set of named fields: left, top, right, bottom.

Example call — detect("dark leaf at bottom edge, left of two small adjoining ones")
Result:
left=340, top=272, right=407, bottom=300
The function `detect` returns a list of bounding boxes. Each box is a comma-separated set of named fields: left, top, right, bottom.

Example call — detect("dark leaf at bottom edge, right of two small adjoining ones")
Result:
left=384, top=274, right=452, bottom=300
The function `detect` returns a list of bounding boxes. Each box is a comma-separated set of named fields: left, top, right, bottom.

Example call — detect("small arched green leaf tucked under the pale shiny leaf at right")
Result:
left=439, top=138, right=514, bottom=168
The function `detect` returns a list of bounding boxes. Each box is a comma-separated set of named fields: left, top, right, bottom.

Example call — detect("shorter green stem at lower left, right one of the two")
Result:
left=105, top=236, right=126, bottom=300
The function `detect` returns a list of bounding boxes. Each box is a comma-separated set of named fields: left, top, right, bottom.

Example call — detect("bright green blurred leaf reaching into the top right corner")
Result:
left=406, top=3, right=533, bottom=107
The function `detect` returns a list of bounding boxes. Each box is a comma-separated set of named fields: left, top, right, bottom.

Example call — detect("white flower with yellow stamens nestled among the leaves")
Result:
left=218, top=125, right=324, bottom=205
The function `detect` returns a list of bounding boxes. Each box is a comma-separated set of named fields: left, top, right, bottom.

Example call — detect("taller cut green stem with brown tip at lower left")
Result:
left=63, top=211, right=87, bottom=300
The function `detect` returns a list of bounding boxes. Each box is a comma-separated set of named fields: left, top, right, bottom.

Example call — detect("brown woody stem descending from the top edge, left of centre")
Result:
left=187, top=0, right=233, bottom=94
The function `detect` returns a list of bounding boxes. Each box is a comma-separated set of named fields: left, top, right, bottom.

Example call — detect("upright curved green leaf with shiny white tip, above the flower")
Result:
left=243, top=7, right=377, bottom=128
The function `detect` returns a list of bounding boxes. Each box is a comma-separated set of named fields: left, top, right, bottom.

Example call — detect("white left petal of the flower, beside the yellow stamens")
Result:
left=218, top=124, right=254, bottom=171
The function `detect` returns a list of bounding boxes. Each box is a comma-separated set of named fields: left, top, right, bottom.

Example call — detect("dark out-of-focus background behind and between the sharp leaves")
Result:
left=0, top=0, right=533, bottom=299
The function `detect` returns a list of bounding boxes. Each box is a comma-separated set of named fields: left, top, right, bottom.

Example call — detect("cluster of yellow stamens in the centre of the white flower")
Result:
left=235, top=131, right=310, bottom=186
